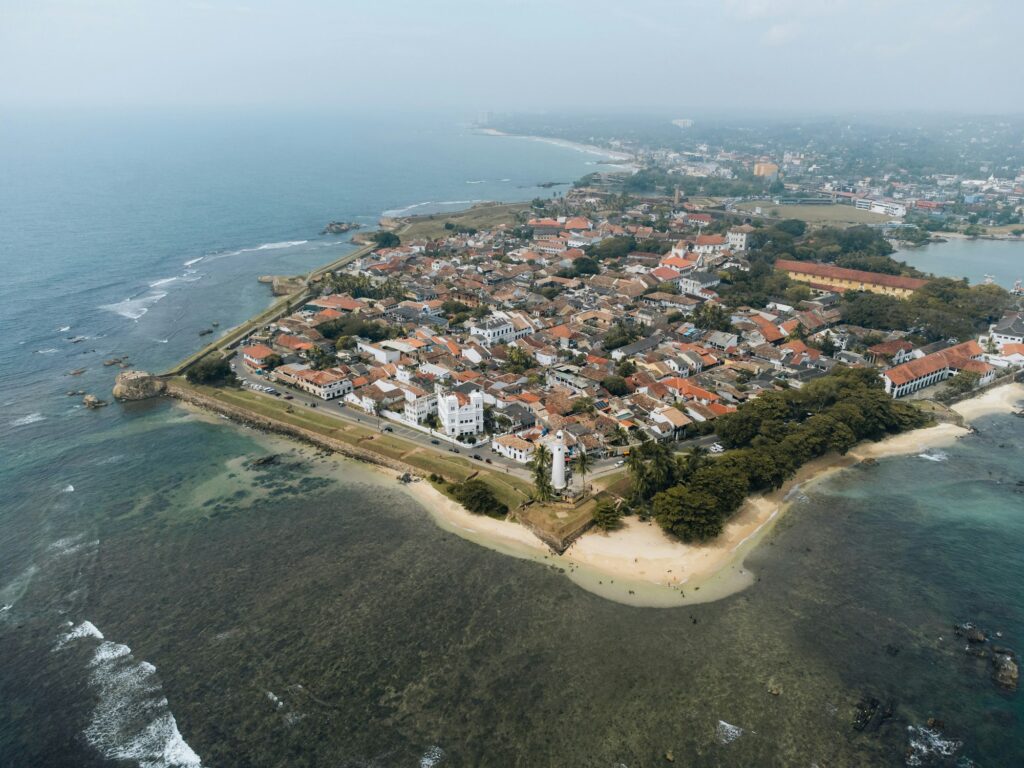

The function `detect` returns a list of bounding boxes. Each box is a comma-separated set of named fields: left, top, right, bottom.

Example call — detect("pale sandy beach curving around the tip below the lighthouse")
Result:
left=395, top=403, right=1011, bottom=607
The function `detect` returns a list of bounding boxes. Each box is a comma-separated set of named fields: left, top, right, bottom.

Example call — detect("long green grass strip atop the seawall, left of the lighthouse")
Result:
left=182, top=382, right=532, bottom=509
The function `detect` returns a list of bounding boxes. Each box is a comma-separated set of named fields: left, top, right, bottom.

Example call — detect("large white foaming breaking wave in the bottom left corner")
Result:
left=55, top=622, right=202, bottom=768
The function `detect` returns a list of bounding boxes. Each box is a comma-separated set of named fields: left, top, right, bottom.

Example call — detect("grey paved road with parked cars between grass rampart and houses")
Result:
left=231, top=356, right=718, bottom=480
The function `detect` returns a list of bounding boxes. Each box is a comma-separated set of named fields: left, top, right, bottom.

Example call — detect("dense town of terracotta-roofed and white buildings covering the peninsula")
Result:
left=220, top=199, right=1024, bottom=481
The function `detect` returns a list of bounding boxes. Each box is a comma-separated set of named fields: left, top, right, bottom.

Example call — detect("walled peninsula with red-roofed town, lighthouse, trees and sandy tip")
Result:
left=119, top=180, right=1024, bottom=605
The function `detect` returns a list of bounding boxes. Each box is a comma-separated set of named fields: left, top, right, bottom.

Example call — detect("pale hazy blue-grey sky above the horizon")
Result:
left=0, top=0, right=1024, bottom=115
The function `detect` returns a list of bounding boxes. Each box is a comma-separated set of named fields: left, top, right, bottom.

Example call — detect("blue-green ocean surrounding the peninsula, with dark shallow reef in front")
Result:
left=0, top=114, right=1024, bottom=768
